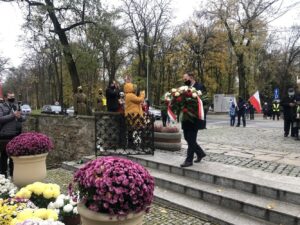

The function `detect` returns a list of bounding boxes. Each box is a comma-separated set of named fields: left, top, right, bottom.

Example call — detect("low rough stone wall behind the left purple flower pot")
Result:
left=23, top=115, right=95, bottom=167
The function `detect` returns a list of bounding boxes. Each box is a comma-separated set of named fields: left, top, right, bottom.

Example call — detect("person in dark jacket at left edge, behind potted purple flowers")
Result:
left=0, top=93, right=25, bottom=177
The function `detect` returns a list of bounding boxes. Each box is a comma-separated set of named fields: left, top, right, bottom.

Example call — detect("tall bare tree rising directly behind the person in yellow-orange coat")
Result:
left=122, top=0, right=171, bottom=99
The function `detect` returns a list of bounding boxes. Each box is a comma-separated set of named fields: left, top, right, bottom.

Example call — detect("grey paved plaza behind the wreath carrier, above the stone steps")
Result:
left=158, top=115, right=300, bottom=177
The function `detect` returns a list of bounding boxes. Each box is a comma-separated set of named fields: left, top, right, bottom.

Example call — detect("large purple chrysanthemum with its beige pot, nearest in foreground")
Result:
left=70, top=157, right=154, bottom=225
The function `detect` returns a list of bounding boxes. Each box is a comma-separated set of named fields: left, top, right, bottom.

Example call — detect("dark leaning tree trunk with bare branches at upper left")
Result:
left=1, top=0, right=97, bottom=91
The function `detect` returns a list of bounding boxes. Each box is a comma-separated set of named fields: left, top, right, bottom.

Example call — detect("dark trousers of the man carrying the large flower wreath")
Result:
left=183, top=129, right=205, bottom=162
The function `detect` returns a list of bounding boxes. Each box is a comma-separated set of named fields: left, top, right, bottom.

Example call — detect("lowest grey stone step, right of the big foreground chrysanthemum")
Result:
left=154, top=187, right=278, bottom=225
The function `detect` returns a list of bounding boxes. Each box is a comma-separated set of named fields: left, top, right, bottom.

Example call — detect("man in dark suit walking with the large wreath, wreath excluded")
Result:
left=180, top=73, right=206, bottom=167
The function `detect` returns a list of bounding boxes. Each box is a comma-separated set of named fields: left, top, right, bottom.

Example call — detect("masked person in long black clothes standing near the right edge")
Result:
left=281, top=88, right=297, bottom=137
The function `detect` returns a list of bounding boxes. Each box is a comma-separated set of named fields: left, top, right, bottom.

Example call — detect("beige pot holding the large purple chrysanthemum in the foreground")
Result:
left=77, top=203, right=145, bottom=225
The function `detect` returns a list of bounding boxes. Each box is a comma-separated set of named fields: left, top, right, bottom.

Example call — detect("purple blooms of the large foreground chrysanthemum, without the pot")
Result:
left=74, top=157, right=154, bottom=216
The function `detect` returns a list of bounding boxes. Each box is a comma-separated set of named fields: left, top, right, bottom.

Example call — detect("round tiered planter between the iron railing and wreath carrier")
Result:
left=154, top=132, right=181, bottom=151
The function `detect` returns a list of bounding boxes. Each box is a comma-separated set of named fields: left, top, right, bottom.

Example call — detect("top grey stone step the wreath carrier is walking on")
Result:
left=128, top=151, right=300, bottom=205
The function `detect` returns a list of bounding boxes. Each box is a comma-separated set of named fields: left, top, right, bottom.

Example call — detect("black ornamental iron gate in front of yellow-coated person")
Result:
left=95, top=112, right=155, bottom=156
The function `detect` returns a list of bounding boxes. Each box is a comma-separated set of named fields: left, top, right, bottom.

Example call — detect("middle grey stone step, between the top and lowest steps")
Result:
left=148, top=168, right=300, bottom=225
